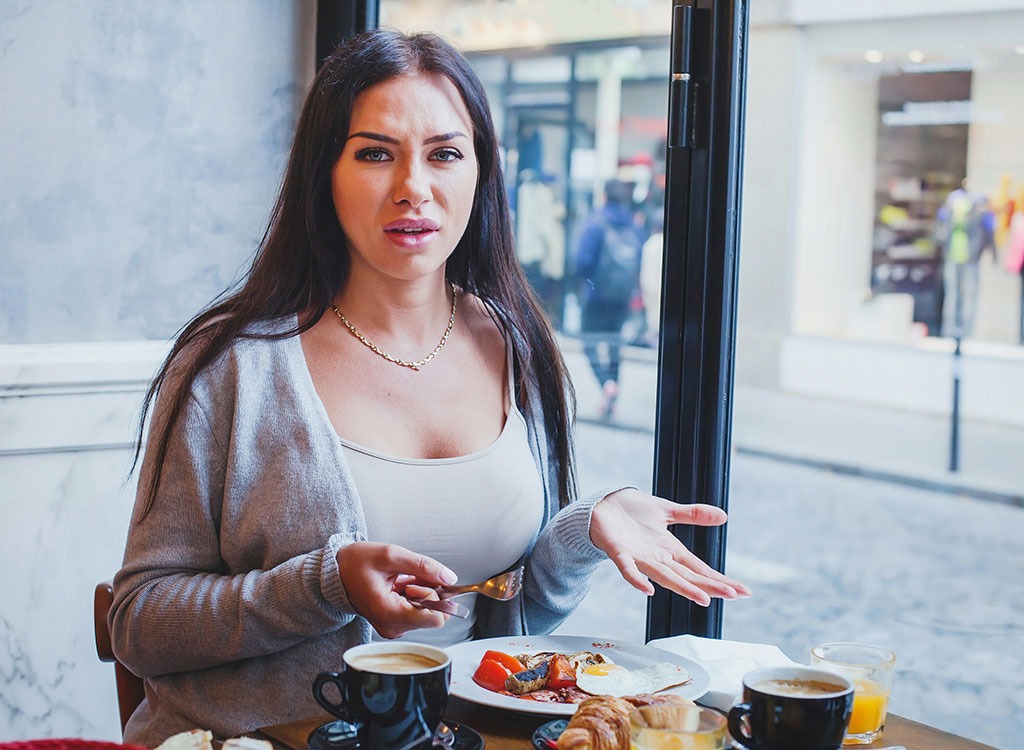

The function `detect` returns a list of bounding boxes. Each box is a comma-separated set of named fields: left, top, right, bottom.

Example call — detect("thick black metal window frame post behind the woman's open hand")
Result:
left=647, top=0, right=748, bottom=640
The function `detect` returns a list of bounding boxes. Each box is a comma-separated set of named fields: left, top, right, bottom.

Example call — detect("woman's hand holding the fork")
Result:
left=338, top=542, right=457, bottom=638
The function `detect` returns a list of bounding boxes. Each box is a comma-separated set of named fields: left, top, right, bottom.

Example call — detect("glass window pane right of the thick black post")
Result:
left=724, top=0, right=1024, bottom=747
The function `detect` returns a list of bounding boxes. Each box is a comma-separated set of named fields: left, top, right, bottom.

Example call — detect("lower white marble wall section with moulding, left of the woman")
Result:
left=0, top=342, right=165, bottom=741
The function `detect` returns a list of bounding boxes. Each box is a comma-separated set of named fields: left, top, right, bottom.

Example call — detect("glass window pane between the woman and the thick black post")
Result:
left=381, top=0, right=671, bottom=642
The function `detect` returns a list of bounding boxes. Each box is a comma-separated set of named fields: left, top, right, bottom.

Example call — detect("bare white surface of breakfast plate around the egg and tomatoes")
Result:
left=445, top=635, right=711, bottom=716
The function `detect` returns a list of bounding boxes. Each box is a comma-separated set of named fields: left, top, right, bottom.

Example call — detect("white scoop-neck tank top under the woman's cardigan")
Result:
left=339, top=348, right=544, bottom=645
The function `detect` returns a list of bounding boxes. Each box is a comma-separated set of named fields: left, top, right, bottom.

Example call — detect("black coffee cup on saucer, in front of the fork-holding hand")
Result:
left=313, top=641, right=452, bottom=750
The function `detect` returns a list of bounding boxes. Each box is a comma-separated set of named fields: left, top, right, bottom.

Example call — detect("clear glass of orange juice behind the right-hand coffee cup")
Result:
left=811, top=642, right=896, bottom=745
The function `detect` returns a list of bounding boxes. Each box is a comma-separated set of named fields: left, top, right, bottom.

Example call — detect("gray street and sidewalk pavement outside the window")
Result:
left=557, top=347, right=1024, bottom=749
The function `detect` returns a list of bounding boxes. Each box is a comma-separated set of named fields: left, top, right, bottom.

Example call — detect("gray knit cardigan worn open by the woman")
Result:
left=109, top=318, right=607, bottom=747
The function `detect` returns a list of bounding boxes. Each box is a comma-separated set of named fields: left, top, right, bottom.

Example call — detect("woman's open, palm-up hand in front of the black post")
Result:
left=590, top=488, right=751, bottom=607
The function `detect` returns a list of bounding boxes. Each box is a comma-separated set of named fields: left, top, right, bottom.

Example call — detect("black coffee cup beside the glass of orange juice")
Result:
left=729, top=667, right=853, bottom=750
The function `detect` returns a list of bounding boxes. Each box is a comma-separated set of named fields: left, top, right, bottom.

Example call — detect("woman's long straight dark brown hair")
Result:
left=132, top=30, right=575, bottom=515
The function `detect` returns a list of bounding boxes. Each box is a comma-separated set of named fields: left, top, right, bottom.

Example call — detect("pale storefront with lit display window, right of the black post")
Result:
left=737, top=2, right=1024, bottom=424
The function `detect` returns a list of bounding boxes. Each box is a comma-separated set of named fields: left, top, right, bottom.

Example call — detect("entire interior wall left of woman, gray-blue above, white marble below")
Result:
left=0, top=0, right=315, bottom=741
